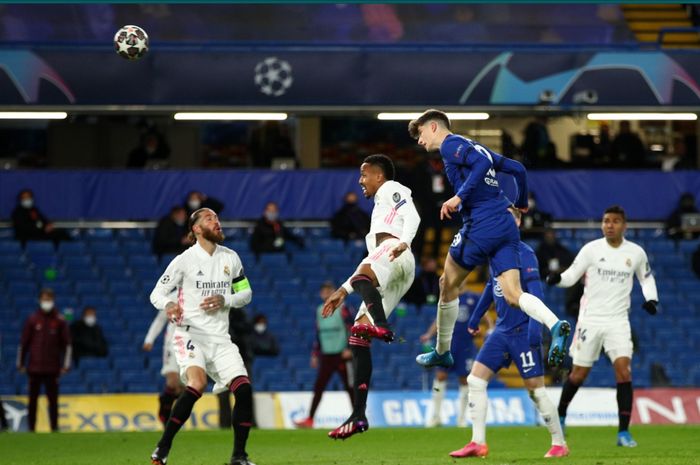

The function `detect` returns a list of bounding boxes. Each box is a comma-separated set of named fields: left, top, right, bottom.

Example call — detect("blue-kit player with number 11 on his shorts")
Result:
left=450, top=209, right=569, bottom=457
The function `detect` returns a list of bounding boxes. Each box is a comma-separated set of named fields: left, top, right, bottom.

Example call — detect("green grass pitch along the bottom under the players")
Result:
left=0, top=426, right=700, bottom=465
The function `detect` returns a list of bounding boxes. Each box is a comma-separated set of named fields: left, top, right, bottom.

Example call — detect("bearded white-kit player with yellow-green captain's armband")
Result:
left=151, top=208, right=253, bottom=465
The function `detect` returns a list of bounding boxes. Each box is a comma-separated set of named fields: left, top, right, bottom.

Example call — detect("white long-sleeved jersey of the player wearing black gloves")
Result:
left=558, top=238, right=659, bottom=324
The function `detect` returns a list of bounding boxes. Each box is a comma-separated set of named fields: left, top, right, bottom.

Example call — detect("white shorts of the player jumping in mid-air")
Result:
left=355, top=239, right=416, bottom=324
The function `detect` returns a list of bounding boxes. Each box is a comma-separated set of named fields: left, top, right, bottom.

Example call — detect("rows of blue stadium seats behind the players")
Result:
left=0, top=228, right=700, bottom=395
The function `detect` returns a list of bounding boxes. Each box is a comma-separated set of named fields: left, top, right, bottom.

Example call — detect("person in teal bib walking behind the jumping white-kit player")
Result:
left=294, top=281, right=353, bottom=428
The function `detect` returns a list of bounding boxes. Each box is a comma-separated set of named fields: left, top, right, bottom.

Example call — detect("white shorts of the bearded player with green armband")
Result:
left=173, top=329, right=248, bottom=394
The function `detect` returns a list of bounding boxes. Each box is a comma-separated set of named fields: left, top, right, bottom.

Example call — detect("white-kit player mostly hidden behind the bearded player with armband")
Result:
left=143, top=306, right=184, bottom=425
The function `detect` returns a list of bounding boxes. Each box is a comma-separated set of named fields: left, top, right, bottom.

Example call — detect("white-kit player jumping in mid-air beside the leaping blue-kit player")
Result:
left=322, top=154, right=420, bottom=439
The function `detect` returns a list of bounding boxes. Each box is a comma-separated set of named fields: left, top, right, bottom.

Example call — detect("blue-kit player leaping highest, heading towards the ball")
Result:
left=408, top=110, right=571, bottom=367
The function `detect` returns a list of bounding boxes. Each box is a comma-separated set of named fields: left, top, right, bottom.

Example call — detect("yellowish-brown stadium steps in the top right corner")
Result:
left=622, top=3, right=700, bottom=48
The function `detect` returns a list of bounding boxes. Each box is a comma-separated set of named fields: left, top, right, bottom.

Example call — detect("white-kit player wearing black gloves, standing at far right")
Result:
left=547, top=205, right=659, bottom=447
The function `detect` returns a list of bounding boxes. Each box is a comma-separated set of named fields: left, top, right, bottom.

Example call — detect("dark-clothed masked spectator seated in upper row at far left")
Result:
left=12, top=189, right=70, bottom=246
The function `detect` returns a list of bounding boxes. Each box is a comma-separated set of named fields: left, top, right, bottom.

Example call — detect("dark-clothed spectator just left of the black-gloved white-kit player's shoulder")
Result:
left=535, top=229, right=583, bottom=317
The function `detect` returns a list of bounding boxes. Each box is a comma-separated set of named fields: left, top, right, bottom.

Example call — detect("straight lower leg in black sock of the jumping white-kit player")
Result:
left=328, top=336, right=372, bottom=439
